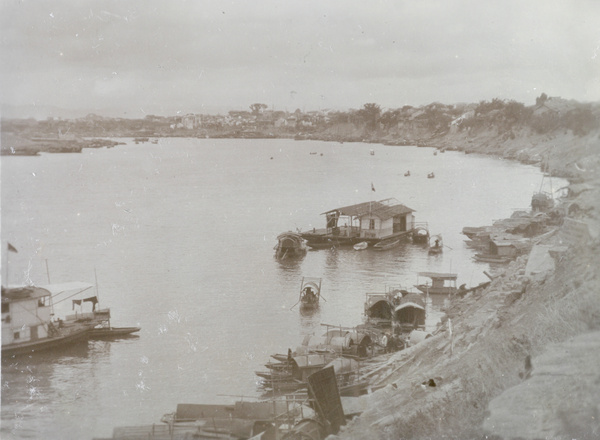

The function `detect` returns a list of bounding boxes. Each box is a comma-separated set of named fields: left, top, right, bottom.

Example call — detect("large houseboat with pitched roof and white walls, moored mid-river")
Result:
left=301, top=198, right=415, bottom=249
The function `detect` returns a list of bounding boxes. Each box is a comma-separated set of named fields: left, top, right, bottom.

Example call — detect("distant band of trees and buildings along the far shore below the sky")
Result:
left=2, top=93, right=600, bottom=139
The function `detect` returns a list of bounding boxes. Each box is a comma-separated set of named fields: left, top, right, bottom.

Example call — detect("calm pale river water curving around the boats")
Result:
left=1, top=138, right=561, bottom=439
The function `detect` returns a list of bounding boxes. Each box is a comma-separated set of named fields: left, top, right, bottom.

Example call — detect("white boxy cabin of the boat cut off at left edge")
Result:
left=2, top=286, right=52, bottom=347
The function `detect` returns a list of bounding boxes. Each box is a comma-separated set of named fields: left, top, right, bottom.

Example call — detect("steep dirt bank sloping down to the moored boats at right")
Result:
left=328, top=126, right=600, bottom=439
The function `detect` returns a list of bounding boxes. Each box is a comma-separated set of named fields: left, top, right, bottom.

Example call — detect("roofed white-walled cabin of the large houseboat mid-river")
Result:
left=323, top=199, right=414, bottom=239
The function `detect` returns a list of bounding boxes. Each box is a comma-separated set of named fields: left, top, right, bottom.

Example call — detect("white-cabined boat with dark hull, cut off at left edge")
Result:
left=2, top=283, right=93, bottom=358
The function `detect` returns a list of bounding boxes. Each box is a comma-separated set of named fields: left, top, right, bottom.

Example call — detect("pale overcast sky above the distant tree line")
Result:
left=0, top=0, right=600, bottom=117
